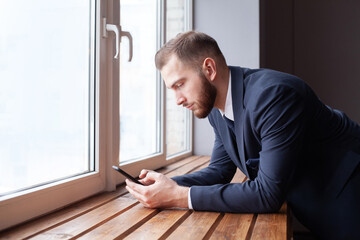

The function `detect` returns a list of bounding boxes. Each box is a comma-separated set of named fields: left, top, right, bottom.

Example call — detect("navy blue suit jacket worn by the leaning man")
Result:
left=174, top=67, right=360, bottom=239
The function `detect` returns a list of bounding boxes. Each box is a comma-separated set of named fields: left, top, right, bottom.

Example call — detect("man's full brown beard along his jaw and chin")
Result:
left=194, top=72, right=217, bottom=118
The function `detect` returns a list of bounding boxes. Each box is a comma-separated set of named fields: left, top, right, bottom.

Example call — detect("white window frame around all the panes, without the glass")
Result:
left=0, top=0, right=193, bottom=231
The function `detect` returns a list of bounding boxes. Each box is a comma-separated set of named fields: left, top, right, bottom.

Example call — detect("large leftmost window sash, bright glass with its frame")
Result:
left=0, top=0, right=104, bottom=230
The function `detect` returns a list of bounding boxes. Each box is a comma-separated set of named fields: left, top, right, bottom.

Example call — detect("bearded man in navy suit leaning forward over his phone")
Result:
left=126, top=32, right=360, bottom=239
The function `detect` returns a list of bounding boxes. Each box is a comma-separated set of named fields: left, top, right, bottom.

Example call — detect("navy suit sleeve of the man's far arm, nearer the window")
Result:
left=172, top=113, right=236, bottom=187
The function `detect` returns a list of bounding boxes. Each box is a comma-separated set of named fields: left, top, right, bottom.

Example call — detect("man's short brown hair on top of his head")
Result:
left=155, top=31, right=226, bottom=70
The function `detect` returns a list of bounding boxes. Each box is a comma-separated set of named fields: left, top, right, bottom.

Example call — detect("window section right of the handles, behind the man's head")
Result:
left=119, top=0, right=192, bottom=176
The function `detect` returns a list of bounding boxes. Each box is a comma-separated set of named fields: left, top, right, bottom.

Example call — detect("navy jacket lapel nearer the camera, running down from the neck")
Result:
left=230, top=67, right=249, bottom=177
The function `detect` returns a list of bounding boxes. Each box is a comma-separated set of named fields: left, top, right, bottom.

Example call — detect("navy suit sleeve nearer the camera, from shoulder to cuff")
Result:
left=191, top=86, right=305, bottom=213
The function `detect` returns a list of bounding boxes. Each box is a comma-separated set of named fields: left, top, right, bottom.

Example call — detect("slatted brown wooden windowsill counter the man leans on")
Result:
left=0, top=156, right=292, bottom=240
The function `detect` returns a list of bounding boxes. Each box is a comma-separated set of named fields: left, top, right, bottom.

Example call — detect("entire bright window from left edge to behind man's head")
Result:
left=0, top=0, right=192, bottom=230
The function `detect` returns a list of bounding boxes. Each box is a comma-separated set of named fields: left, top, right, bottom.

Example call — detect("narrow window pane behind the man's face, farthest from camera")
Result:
left=166, top=0, right=190, bottom=156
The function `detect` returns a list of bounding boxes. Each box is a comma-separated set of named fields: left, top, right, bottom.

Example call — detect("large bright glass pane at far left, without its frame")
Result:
left=0, top=0, right=94, bottom=195
